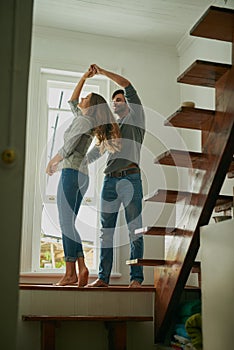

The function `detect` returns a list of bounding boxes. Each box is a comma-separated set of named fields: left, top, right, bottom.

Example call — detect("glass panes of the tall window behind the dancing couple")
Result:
left=40, top=80, right=100, bottom=270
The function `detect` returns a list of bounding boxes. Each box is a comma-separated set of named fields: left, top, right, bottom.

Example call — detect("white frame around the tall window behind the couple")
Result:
left=21, top=68, right=121, bottom=276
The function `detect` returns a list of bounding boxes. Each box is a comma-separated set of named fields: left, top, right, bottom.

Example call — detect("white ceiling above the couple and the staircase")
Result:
left=33, top=0, right=234, bottom=46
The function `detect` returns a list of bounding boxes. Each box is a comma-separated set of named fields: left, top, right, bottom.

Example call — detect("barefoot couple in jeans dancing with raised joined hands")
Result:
left=46, top=64, right=145, bottom=288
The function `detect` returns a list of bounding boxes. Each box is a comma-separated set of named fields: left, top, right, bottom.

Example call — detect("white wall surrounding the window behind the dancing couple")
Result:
left=22, top=27, right=184, bottom=283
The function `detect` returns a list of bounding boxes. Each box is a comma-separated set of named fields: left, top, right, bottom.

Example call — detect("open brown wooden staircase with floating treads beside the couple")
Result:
left=127, top=6, right=234, bottom=343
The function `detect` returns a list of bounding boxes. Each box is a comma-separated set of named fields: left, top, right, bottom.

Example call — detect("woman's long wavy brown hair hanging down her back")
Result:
left=88, top=92, right=121, bottom=153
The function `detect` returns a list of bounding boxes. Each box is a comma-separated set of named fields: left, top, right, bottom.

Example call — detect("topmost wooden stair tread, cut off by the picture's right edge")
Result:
left=190, top=6, right=234, bottom=42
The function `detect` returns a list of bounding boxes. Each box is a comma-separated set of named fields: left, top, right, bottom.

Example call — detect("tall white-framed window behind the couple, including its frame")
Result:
left=21, top=69, right=119, bottom=273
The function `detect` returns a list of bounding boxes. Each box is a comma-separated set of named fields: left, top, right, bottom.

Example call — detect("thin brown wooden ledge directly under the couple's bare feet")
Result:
left=19, top=283, right=155, bottom=292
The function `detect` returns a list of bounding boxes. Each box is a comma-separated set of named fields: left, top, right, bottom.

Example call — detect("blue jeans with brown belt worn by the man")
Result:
left=98, top=173, right=144, bottom=283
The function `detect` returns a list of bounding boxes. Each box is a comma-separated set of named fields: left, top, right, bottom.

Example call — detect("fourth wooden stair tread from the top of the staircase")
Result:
left=154, top=150, right=234, bottom=171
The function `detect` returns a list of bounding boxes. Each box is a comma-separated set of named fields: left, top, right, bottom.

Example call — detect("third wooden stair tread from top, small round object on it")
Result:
left=164, top=107, right=215, bottom=130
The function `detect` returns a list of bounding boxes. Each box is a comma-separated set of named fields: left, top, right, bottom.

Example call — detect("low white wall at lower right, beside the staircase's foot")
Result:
left=201, top=220, right=234, bottom=350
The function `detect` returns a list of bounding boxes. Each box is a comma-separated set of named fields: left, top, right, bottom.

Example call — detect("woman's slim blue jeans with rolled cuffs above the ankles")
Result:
left=57, top=169, right=89, bottom=262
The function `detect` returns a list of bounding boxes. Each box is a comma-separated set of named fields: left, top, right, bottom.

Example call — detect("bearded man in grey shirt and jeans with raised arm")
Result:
left=88, top=64, right=145, bottom=288
